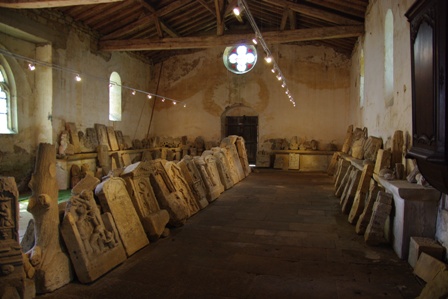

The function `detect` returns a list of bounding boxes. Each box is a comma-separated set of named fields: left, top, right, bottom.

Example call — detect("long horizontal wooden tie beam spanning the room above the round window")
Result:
left=99, top=25, right=364, bottom=51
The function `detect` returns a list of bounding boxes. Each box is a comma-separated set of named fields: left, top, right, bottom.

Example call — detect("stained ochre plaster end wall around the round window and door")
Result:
left=150, top=45, right=350, bottom=149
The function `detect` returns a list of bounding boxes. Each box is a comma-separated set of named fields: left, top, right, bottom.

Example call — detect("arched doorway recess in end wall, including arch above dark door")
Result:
left=221, top=104, right=258, bottom=164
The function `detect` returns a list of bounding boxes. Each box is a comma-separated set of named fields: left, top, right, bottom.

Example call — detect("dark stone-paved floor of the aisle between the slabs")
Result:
left=39, top=169, right=422, bottom=299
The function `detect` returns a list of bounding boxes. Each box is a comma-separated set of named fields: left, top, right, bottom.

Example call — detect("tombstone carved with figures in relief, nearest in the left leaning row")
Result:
left=61, top=189, right=127, bottom=283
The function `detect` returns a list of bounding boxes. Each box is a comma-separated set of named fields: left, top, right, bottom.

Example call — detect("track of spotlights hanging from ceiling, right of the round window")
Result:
left=233, top=0, right=296, bottom=107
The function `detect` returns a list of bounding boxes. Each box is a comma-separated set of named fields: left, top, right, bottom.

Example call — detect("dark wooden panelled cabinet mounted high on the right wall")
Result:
left=406, top=0, right=448, bottom=193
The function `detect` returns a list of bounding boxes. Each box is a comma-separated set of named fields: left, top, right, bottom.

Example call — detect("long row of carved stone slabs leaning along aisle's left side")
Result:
left=49, top=136, right=250, bottom=290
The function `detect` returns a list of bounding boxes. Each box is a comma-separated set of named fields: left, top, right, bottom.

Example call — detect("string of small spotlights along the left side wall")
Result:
left=0, top=48, right=187, bottom=107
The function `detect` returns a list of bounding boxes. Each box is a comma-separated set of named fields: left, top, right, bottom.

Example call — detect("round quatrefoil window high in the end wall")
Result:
left=222, top=45, right=257, bottom=74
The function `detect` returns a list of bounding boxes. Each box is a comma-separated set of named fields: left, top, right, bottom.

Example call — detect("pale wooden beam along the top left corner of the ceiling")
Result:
left=0, top=0, right=123, bottom=9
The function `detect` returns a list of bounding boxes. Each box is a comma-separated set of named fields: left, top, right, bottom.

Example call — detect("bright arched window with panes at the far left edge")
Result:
left=0, top=56, right=17, bottom=134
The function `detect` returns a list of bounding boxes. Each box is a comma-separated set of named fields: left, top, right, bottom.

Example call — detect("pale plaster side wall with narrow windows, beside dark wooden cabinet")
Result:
left=349, top=0, right=414, bottom=146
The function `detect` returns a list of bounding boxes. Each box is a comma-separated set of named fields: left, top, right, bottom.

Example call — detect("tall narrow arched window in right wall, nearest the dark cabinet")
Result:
left=384, top=9, right=394, bottom=106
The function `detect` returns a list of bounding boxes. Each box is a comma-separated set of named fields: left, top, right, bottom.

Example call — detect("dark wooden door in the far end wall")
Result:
left=226, top=116, right=258, bottom=164
